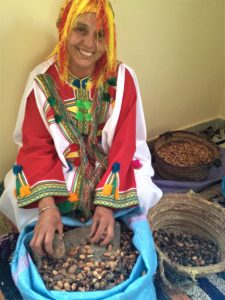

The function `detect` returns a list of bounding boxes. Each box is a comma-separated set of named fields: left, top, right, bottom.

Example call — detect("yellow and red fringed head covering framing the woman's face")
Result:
left=50, top=0, right=117, bottom=87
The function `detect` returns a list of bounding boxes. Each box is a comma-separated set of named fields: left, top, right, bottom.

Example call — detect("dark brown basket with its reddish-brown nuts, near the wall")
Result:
left=153, top=131, right=221, bottom=181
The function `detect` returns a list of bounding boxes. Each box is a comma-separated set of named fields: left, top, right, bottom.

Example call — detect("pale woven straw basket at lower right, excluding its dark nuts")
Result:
left=148, top=193, right=225, bottom=285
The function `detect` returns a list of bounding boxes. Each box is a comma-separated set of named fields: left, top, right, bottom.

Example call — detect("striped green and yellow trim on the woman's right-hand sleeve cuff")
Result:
left=94, top=189, right=138, bottom=208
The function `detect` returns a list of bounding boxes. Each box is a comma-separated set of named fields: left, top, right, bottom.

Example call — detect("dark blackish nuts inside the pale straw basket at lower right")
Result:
left=153, top=229, right=221, bottom=267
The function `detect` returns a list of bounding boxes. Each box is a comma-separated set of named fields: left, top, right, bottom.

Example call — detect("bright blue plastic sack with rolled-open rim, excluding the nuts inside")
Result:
left=11, top=211, right=157, bottom=300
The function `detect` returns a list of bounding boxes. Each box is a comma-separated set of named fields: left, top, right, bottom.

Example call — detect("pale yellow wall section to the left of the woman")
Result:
left=0, top=0, right=62, bottom=180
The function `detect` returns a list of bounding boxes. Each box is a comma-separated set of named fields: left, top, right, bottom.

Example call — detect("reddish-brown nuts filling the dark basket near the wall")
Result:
left=157, top=141, right=213, bottom=167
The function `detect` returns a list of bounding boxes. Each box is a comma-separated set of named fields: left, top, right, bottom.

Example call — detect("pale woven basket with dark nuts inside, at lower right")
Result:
left=148, top=193, right=225, bottom=282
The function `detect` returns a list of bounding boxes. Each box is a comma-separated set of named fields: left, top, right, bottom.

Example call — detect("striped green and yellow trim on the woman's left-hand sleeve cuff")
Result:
left=17, top=181, right=69, bottom=207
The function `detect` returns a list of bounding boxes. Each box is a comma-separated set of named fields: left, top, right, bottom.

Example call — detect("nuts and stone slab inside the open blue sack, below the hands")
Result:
left=33, top=222, right=138, bottom=292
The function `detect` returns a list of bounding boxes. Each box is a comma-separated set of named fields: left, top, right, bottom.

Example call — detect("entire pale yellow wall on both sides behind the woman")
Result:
left=0, top=0, right=225, bottom=180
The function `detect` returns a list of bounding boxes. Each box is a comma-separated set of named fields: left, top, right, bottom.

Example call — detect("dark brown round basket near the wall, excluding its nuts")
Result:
left=153, top=131, right=221, bottom=181
